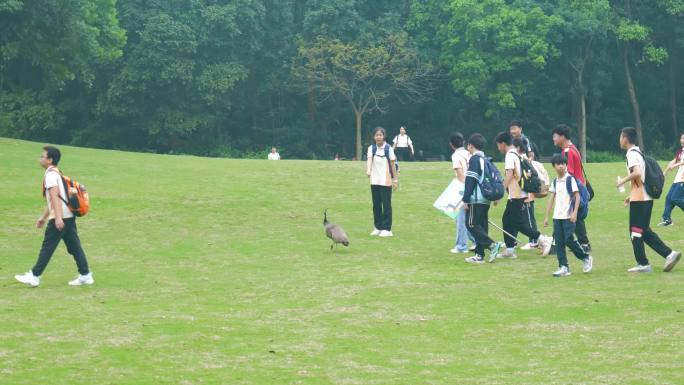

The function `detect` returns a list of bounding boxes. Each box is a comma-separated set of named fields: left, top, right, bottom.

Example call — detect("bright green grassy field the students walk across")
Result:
left=0, top=139, right=684, bottom=385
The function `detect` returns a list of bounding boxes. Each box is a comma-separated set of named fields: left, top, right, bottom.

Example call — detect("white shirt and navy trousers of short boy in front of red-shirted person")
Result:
left=549, top=172, right=589, bottom=267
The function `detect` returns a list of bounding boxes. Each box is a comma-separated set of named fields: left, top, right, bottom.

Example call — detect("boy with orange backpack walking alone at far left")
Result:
left=14, top=146, right=95, bottom=287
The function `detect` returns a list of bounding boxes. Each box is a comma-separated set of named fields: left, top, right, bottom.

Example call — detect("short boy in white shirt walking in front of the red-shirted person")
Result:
left=544, top=154, right=594, bottom=277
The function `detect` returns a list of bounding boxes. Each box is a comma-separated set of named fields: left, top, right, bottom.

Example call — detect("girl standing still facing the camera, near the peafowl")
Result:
left=366, top=127, right=399, bottom=237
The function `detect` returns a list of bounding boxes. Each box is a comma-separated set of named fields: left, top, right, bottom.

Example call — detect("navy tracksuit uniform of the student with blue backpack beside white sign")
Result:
left=463, top=151, right=495, bottom=257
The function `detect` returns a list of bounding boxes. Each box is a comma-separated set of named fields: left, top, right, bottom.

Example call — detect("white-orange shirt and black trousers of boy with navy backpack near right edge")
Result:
left=627, top=146, right=672, bottom=266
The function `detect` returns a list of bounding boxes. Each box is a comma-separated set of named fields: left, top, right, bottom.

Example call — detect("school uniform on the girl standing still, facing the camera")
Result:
left=367, top=143, right=397, bottom=231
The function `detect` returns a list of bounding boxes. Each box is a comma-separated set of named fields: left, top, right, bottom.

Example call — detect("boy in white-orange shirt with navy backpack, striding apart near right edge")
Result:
left=616, top=127, right=682, bottom=273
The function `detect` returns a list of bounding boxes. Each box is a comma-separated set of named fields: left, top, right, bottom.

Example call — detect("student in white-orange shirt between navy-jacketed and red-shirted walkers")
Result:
left=495, top=132, right=553, bottom=258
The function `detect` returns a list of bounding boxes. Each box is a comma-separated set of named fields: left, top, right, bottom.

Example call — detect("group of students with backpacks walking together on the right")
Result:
left=450, top=121, right=684, bottom=277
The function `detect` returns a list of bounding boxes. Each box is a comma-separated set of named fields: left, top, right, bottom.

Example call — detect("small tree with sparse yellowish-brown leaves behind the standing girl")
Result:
left=293, top=35, right=435, bottom=159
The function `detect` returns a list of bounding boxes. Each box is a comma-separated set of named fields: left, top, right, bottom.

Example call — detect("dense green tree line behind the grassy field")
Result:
left=0, top=0, right=684, bottom=160
